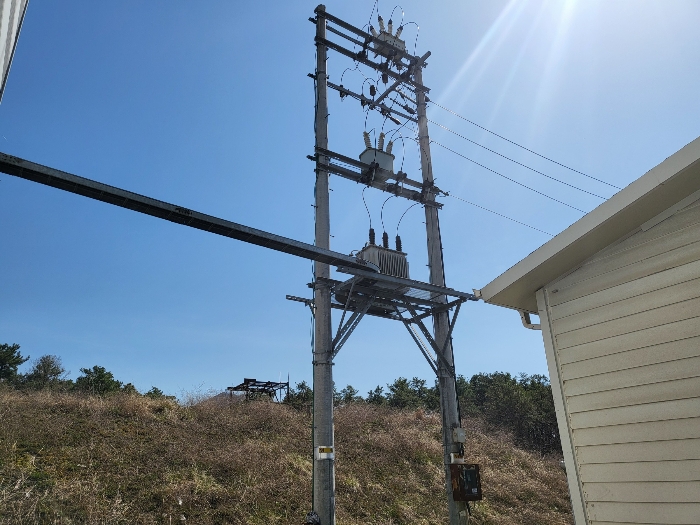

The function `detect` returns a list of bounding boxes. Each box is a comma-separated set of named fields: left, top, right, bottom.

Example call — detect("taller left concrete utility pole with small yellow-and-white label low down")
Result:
left=313, top=5, right=335, bottom=525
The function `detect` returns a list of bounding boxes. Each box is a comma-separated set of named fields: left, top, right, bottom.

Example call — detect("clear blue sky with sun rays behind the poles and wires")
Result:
left=0, top=0, right=700, bottom=395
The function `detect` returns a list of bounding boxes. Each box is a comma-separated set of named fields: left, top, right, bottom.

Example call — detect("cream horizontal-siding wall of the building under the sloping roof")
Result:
left=538, top=195, right=700, bottom=525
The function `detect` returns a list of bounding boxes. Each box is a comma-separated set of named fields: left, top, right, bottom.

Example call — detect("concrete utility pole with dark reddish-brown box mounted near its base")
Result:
left=414, top=66, right=469, bottom=525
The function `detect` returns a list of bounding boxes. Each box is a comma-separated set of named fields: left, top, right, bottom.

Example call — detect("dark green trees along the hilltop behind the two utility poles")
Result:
left=284, top=372, right=561, bottom=454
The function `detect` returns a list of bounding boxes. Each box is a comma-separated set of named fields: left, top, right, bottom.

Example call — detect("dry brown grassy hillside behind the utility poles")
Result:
left=0, top=389, right=572, bottom=525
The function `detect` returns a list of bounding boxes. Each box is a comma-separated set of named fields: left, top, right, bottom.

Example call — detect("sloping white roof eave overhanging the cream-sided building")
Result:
left=481, top=137, right=700, bottom=312
